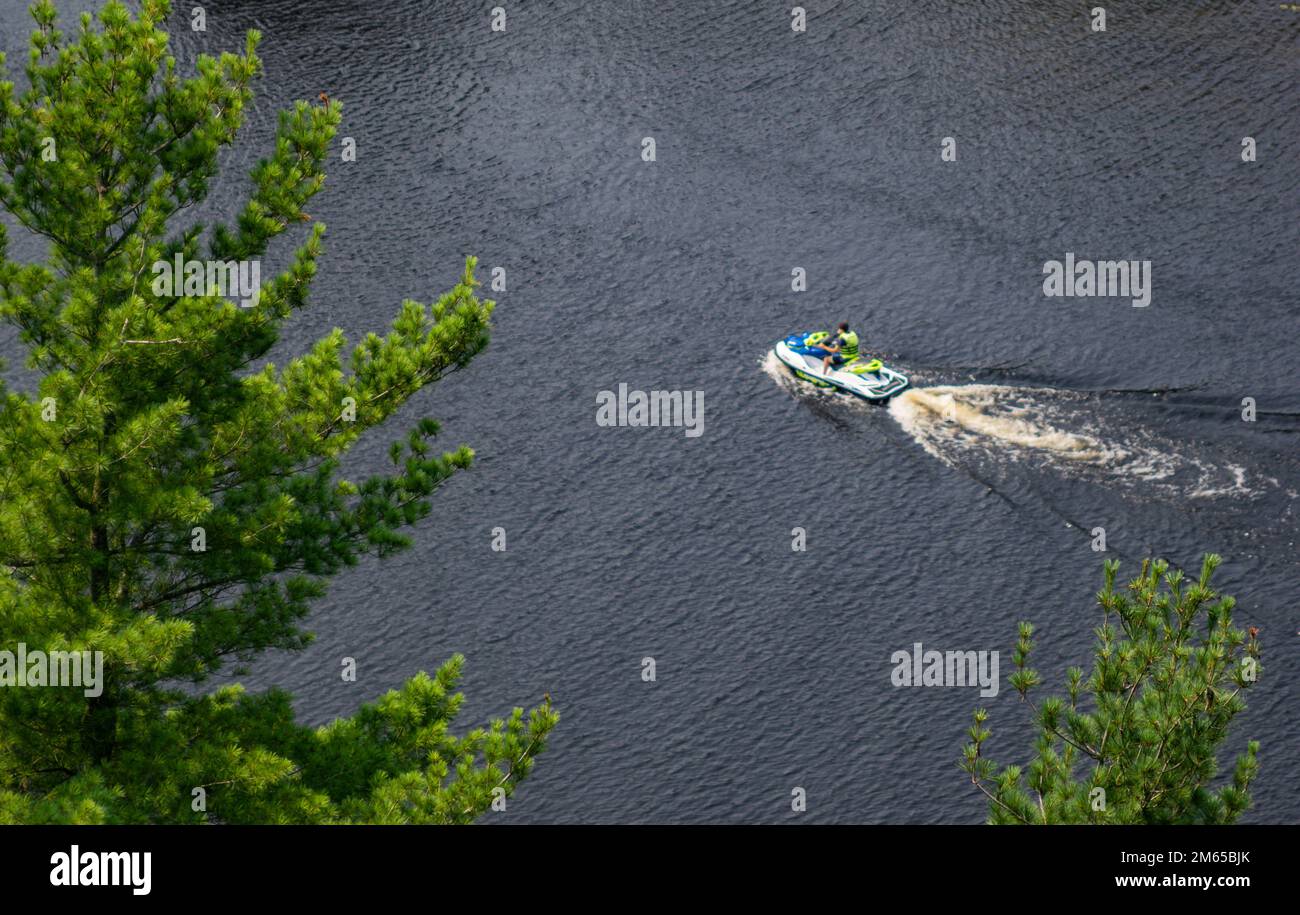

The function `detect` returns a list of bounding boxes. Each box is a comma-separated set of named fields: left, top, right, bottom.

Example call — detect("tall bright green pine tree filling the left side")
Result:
left=0, top=0, right=558, bottom=823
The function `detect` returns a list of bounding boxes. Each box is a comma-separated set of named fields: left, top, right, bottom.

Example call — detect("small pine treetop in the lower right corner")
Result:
left=962, top=554, right=1261, bottom=824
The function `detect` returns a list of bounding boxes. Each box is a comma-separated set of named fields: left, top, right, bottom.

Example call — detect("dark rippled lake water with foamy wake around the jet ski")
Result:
left=0, top=0, right=1300, bottom=823
